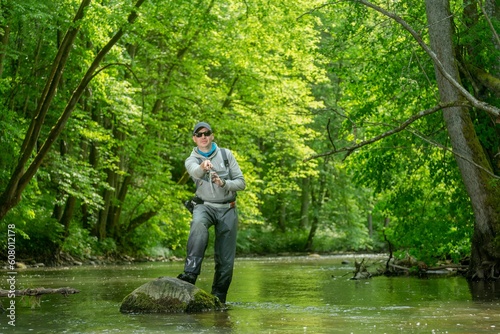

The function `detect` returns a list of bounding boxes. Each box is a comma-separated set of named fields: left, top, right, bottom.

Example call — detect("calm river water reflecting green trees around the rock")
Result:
left=0, top=256, right=500, bottom=334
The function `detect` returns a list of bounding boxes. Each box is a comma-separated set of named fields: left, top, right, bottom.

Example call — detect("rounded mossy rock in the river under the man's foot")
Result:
left=120, top=277, right=222, bottom=313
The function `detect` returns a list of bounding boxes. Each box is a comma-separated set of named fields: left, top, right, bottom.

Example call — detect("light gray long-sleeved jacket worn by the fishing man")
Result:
left=184, top=147, right=246, bottom=203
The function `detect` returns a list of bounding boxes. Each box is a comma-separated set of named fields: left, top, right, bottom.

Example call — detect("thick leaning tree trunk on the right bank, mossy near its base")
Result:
left=426, top=0, right=500, bottom=280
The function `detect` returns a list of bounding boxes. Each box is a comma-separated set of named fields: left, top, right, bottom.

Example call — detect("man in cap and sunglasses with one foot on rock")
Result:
left=177, top=122, right=246, bottom=303
